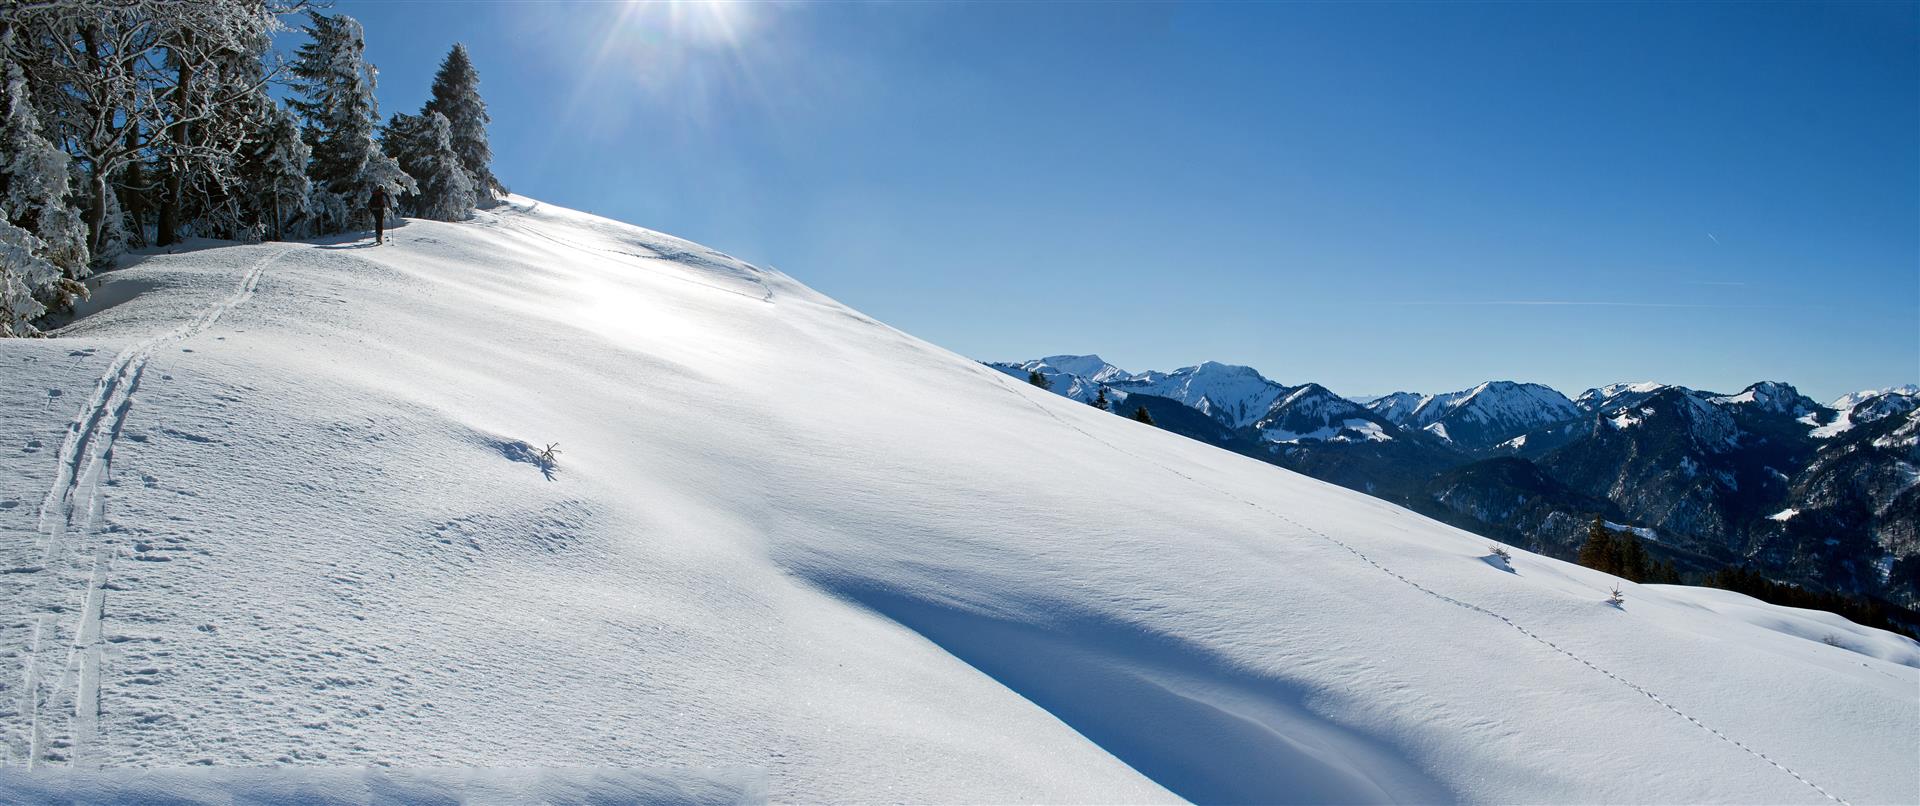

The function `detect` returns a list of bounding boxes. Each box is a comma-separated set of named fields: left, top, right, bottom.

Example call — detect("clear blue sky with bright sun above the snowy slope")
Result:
left=322, top=2, right=1920, bottom=399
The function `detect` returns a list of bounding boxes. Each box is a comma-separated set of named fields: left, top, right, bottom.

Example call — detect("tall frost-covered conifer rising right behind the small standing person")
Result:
left=292, top=12, right=415, bottom=232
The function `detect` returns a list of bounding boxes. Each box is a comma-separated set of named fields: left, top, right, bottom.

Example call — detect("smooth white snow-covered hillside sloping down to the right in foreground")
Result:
left=0, top=198, right=1920, bottom=804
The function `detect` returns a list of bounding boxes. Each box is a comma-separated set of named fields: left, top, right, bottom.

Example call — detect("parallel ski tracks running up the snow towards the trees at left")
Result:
left=8, top=246, right=294, bottom=770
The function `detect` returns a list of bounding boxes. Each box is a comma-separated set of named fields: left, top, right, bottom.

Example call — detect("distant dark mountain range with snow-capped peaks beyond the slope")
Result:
left=989, top=355, right=1920, bottom=606
